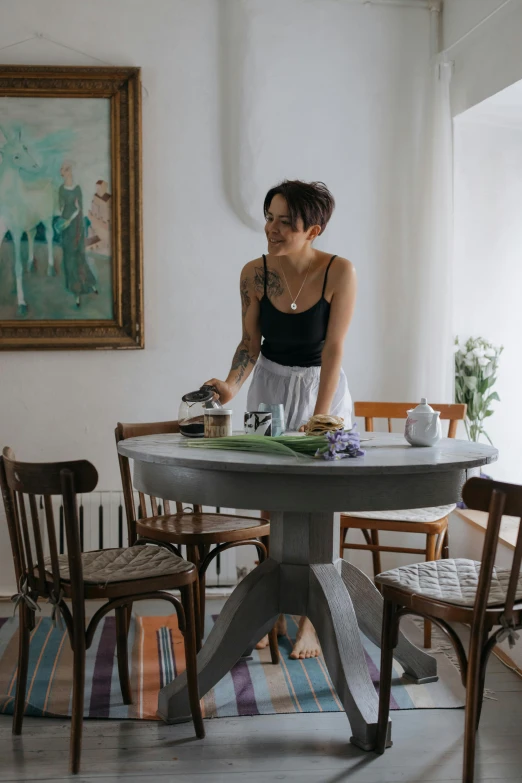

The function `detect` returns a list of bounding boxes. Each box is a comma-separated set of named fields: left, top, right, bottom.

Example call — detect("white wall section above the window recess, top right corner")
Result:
left=442, top=0, right=522, bottom=115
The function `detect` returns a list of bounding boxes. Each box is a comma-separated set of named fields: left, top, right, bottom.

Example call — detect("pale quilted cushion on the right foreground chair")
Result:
left=376, top=558, right=522, bottom=606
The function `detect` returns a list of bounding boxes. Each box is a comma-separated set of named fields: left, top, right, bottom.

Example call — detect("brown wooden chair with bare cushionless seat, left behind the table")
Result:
left=115, top=421, right=279, bottom=664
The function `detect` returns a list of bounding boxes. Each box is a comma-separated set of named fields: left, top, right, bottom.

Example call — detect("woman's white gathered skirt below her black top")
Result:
left=247, top=354, right=352, bottom=431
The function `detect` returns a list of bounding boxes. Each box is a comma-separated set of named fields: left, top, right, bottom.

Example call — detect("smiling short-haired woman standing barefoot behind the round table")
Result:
left=207, top=180, right=356, bottom=658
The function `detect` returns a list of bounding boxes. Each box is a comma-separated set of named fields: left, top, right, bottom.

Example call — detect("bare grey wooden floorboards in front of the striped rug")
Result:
left=0, top=607, right=522, bottom=783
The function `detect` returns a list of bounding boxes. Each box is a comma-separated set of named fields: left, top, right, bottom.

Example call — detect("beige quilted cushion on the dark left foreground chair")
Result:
left=45, top=545, right=194, bottom=585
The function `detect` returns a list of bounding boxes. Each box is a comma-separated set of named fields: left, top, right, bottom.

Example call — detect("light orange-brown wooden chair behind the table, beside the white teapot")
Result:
left=340, top=402, right=466, bottom=647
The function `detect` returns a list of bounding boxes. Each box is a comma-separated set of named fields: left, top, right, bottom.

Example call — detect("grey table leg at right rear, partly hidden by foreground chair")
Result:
left=341, top=560, right=438, bottom=683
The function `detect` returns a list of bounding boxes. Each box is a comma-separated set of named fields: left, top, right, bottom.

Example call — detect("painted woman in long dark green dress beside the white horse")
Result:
left=58, top=161, right=98, bottom=307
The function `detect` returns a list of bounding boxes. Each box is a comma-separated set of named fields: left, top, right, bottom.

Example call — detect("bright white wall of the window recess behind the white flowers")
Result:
left=453, top=112, right=522, bottom=483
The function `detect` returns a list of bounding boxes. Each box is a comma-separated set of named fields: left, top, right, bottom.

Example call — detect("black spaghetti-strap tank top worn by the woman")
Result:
left=259, top=256, right=337, bottom=367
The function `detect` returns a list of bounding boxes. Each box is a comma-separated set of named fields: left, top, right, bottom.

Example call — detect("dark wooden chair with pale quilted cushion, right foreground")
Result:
left=376, top=478, right=522, bottom=783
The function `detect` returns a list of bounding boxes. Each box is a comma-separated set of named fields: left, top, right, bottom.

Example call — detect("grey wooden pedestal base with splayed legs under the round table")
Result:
left=158, top=512, right=437, bottom=750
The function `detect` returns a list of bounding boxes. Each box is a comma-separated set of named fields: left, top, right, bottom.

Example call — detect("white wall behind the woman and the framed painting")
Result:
left=0, top=0, right=429, bottom=592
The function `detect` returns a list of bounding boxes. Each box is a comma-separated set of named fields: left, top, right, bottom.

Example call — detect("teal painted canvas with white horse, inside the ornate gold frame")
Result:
left=0, top=96, right=113, bottom=323
